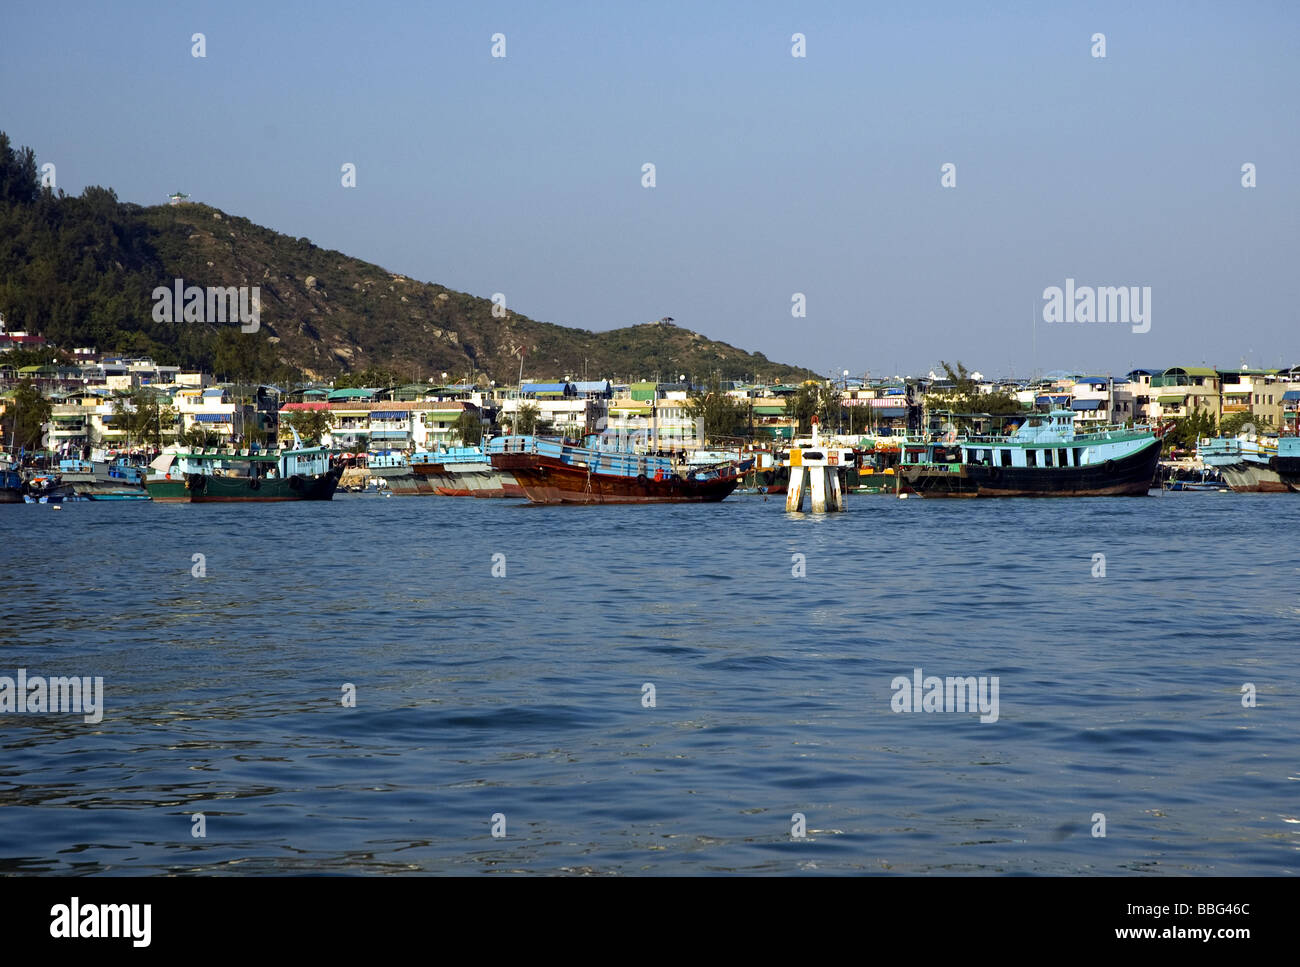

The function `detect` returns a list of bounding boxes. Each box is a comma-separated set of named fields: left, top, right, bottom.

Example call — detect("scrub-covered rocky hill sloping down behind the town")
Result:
left=0, top=134, right=811, bottom=382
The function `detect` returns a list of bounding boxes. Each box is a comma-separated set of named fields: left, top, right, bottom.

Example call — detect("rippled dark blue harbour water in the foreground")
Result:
left=0, top=493, right=1300, bottom=875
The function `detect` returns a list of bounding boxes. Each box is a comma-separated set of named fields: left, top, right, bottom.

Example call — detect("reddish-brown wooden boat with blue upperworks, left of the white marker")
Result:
left=490, top=437, right=751, bottom=504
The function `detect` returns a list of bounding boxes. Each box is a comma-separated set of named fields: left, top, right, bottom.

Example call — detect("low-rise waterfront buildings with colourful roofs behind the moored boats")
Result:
left=0, top=321, right=1300, bottom=459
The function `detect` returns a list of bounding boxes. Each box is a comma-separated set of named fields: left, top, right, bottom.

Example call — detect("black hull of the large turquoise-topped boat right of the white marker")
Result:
left=902, top=438, right=1160, bottom=496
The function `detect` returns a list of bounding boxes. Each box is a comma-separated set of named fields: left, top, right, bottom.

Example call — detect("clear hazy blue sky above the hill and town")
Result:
left=0, top=0, right=1300, bottom=377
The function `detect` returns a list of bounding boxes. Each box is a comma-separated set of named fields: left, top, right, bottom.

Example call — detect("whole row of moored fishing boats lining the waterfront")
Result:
left=12, top=409, right=1300, bottom=508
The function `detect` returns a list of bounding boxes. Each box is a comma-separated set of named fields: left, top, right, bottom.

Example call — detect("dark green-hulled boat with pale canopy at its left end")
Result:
left=144, top=433, right=343, bottom=503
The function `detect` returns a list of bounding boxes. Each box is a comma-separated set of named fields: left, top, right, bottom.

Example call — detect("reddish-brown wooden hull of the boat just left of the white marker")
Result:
left=491, top=452, right=740, bottom=504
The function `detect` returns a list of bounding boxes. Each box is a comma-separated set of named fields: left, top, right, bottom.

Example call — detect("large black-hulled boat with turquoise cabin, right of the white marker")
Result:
left=898, top=409, right=1161, bottom=496
